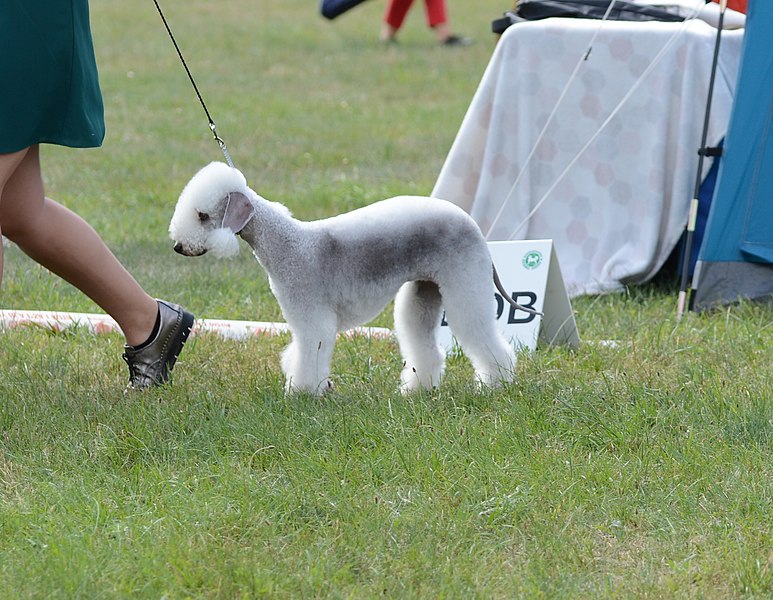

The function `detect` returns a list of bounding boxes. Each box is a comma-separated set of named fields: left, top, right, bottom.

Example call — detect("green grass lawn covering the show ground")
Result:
left=0, top=0, right=773, bottom=598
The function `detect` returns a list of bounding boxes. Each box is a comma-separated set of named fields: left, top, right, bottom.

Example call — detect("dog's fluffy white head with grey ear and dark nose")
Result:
left=169, top=162, right=253, bottom=257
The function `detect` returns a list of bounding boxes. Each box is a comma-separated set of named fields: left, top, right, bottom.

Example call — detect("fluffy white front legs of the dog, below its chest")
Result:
left=282, top=323, right=336, bottom=395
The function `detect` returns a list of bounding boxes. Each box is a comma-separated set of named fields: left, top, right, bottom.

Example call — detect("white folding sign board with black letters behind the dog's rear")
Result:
left=440, top=240, right=580, bottom=351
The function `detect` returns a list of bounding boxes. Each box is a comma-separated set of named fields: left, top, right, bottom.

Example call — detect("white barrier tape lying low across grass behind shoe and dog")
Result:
left=0, top=310, right=392, bottom=340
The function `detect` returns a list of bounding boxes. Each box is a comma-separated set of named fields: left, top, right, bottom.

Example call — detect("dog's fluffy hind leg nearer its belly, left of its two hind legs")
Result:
left=395, top=281, right=445, bottom=394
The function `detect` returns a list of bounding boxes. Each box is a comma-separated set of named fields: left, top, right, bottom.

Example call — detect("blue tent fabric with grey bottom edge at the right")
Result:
left=693, top=0, right=773, bottom=310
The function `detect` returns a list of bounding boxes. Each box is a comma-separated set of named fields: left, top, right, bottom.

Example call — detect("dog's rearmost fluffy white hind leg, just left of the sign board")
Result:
left=443, top=281, right=516, bottom=387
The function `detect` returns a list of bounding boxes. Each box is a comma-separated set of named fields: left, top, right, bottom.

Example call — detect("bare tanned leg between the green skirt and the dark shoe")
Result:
left=0, top=146, right=158, bottom=346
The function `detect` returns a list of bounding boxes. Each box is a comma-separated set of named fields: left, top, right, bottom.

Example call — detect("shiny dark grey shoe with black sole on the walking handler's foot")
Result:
left=123, top=300, right=193, bottom=390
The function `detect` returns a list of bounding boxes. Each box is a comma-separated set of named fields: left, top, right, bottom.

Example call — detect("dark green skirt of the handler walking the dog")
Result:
left=0, top=0, right=105, bottom=153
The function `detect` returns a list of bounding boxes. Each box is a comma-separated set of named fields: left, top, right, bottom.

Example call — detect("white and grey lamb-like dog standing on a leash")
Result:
left=169, top=162, right=516, bottom=394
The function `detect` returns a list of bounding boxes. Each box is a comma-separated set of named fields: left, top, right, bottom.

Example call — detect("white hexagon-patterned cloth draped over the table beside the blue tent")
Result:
left=432, top=18, right=743, bottom=296
